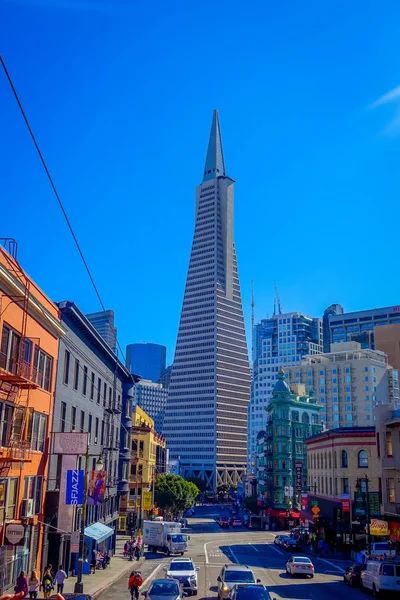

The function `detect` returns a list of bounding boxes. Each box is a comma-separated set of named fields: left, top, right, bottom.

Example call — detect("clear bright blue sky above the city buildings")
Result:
left=0, top=0, right=400, bottom=360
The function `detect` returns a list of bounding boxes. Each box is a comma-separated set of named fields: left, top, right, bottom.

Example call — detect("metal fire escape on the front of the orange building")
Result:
left=0, top=238, right=39, bottom=477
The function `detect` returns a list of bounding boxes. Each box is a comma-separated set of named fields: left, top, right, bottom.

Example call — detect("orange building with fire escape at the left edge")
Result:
left=0, top=240, right=63, bottom=593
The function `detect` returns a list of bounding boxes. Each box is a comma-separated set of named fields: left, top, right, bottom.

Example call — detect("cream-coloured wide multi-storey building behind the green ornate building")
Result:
left=289, top=342, right=399, bottom=429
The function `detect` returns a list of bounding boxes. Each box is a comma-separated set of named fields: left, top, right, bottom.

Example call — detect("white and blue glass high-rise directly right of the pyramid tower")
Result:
left=248, top=312, right=323, bottom=472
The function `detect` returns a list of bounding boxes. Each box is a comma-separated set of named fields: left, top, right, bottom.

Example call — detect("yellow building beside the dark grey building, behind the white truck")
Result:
left=119, top=406, right=166, bottom=531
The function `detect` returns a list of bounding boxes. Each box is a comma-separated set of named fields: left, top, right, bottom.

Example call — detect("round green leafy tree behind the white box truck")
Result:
left=154, top=474, right=199, bottom=517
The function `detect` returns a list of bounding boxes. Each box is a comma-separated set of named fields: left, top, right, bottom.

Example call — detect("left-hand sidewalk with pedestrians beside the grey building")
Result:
left=61, top=535, right=143, bottom=597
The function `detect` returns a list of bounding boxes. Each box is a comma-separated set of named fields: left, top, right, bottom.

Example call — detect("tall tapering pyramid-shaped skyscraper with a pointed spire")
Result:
left=163, top=111, right=250, bottom=488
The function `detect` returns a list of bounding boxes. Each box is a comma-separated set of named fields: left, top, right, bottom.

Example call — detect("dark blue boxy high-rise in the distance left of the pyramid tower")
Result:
left=126, top=343, right=167, bottom=383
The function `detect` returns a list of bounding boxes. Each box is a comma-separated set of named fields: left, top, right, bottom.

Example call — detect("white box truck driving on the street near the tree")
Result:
left=143, top=521, right=189, bottom=556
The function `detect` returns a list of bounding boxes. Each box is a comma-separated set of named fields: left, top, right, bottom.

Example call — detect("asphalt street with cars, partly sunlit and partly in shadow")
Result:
left=99, top=507, right=365, bottom=600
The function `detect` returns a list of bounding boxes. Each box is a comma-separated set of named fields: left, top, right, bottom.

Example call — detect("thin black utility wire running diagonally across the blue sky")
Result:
left=0, top=54, right=128, bottom=368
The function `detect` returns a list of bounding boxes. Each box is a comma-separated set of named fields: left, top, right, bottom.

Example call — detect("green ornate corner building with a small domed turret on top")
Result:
left=256, top=368, right=322, bottom=511
